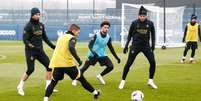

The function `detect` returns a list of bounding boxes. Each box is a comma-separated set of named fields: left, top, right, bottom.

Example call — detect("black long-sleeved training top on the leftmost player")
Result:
left=23, top=19, right=55, bottom=50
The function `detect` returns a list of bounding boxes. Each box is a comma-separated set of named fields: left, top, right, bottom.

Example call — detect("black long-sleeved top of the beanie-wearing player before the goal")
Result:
left=126, top=19, right=155, bottom=47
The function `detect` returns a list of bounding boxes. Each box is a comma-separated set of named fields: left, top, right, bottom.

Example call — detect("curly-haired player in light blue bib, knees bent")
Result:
left=80, top=21, right=121, bottom=85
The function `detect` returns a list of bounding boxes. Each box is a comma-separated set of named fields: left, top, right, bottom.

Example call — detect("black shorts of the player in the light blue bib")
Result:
left=87, top=56, right=113, bottom=67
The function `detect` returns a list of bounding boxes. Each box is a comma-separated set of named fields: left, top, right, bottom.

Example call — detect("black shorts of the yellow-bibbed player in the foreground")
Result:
left=53, top=66, right=80, bottom=81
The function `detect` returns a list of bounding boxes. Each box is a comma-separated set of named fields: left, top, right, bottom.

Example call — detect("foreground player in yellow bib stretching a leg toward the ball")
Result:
left=44, top=24, right=100, bottom=101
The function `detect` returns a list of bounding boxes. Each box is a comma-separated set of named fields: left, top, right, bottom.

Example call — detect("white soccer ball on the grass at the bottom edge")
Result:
left=131, top=90, right=144, bottom=101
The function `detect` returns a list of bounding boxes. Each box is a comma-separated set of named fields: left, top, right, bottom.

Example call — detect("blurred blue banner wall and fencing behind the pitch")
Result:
left=0, top=0, right=201, bottom=41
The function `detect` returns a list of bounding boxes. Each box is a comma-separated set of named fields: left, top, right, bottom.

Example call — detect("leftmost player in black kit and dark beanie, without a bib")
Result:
left=17, top=8, right=55, bottom=96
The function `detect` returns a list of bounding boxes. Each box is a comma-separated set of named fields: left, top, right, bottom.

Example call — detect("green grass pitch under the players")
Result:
left=0, top=41, right=201, bottom=101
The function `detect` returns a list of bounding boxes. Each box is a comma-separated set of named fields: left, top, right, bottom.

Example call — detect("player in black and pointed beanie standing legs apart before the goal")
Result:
left=119, top=6, right=157, bottom=89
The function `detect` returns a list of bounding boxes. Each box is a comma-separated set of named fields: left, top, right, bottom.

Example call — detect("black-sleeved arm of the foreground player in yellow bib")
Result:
left=68, top=38, right=82, bottom=64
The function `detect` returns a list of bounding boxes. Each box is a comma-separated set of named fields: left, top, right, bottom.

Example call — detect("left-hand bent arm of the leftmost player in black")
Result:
left=23, top=25, right=34, bottom=48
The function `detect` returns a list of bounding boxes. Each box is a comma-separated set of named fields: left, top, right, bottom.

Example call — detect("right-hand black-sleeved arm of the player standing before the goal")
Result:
left=151, top=22, right=156, bottom=51
